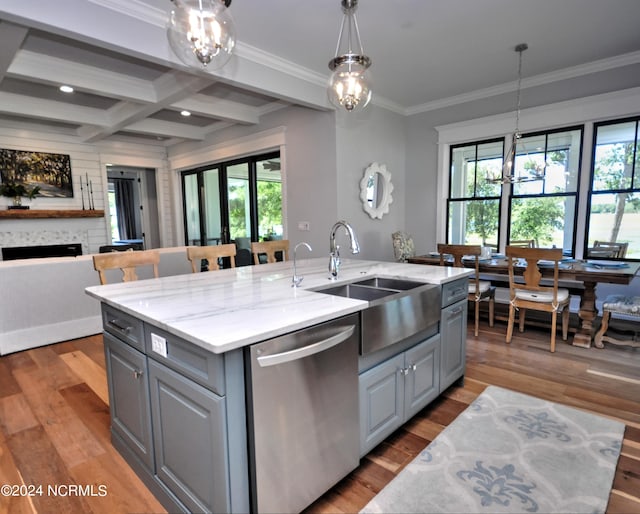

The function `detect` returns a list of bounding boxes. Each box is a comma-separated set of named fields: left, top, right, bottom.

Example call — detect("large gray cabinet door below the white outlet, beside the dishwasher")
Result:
left=149, top=360, right=231, bottom=512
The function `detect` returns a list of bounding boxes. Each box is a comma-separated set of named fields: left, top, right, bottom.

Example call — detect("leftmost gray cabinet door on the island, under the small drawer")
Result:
left=103, top=332, right=153, bottom=471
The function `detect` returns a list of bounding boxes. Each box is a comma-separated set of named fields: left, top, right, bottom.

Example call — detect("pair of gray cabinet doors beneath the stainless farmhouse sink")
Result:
left=359, top=335, right=440, bottom=456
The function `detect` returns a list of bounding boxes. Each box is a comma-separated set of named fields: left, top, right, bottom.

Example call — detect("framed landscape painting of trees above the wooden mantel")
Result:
left=0, top=148, right=73, bottom=198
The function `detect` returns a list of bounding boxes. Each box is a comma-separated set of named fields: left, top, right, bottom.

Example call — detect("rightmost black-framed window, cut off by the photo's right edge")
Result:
left=585, top=118, right=640, bottom=259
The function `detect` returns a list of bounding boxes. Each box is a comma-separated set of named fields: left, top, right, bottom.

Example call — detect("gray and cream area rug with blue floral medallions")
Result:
left=361, top=386, right=624, bottom=514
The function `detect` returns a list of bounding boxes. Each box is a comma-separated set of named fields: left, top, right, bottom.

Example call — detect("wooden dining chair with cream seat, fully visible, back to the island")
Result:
left=505, top=246, right=570, bottom=352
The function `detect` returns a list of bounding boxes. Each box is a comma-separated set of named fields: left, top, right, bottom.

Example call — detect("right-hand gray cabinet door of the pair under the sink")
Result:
left=404, top=336, right=440, bottom=421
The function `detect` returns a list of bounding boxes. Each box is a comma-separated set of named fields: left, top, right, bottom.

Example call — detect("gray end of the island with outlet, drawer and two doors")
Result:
left=102, top=305, right=249, bottom=513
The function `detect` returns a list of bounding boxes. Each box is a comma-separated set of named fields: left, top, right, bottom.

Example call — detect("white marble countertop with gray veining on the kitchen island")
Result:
left=86, top=257, right=473, bottom=353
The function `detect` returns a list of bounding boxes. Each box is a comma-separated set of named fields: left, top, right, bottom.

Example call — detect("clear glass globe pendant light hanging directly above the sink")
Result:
left=327, top=0, right=371, bottom=112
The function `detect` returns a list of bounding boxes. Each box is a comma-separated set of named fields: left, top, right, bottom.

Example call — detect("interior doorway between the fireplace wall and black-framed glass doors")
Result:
left=107, top=165, right=160, bottom=248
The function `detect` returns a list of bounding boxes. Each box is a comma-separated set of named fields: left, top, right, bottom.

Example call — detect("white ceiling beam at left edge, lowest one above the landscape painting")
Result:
left=0, top=92, right=106, bottom=125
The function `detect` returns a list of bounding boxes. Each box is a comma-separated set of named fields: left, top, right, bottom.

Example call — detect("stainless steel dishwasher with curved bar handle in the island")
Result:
left=246, top=314, right=360, bottom=513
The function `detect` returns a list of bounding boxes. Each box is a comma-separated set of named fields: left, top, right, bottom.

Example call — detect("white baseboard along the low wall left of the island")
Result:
left=0, top=315, right=102, bottom=355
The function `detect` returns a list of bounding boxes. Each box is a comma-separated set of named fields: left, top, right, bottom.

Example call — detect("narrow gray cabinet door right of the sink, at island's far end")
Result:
left=440, top=299, right=467, bottom=392
